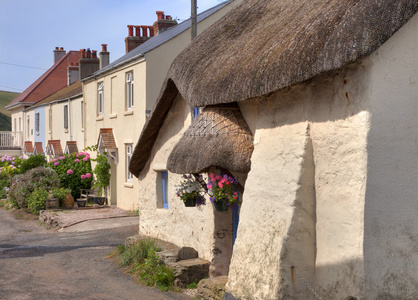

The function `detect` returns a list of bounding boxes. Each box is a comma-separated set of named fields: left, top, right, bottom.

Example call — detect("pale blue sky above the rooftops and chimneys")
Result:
left=0, top=0, right=224, bottom=92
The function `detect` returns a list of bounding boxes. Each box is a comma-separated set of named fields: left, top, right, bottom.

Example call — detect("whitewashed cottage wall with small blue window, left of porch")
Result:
left=138, top=96, right=214, bottom=260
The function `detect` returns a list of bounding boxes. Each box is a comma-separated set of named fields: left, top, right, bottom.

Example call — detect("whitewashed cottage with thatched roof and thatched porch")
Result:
left=130, top=0, right=418, bottom=299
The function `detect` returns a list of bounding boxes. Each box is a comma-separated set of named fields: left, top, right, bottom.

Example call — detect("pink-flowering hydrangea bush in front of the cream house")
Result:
left=47, top=151, right=92, bottom=199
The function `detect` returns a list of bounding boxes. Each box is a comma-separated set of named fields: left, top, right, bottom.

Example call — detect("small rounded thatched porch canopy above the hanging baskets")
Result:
left=167, top=104, right=254, bottom=174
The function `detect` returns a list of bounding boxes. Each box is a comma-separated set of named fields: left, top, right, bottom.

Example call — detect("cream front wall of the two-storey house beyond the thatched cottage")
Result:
left=83, top=59, right=146, bottom=210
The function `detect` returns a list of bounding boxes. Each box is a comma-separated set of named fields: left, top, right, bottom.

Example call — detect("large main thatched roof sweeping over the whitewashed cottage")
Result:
left=130, top=0, right=418, bottom=176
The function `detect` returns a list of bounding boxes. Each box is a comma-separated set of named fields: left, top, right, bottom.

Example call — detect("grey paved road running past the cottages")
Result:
left=0, top=209, right=190, bottom=300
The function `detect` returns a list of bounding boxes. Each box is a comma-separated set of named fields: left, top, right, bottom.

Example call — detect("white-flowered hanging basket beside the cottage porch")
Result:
left=176, top=174, right=206, bottom=206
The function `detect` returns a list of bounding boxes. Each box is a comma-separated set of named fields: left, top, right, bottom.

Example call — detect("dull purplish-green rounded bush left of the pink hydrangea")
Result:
left=10, top=167, right=60, bottom=208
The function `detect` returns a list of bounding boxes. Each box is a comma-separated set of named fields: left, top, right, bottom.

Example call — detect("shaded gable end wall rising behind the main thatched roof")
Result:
left=145, top=0, right=243, bottom=110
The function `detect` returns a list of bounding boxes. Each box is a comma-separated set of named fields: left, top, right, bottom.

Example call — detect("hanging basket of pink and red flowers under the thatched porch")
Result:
left=207, top=173, right=239, bottom=211
